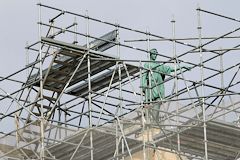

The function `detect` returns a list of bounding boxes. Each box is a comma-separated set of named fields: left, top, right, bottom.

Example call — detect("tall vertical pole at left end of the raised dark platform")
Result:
left=38, top=1, right=45, bottom=160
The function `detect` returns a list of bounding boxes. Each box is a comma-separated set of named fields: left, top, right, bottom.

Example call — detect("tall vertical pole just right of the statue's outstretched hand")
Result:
left=197, top=6, right=208, bottom=160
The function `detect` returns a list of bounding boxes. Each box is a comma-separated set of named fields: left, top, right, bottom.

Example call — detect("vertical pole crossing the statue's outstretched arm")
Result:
left=171, top=16, right=181, bottom=152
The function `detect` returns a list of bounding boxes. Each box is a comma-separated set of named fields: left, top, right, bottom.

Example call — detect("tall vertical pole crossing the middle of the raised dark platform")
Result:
left=86, top=11, right=93, bottom=160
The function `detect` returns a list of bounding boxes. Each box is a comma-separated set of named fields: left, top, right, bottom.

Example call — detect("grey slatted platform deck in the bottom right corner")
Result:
left=155, top=121, right=240, bottom=160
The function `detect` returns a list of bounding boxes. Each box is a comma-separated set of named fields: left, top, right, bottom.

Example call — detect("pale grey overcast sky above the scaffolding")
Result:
left=0, top=0, right=240, bottom=86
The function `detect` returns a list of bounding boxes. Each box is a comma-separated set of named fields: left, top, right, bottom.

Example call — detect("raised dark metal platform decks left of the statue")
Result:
left=28, top=30, right=138, bottom=96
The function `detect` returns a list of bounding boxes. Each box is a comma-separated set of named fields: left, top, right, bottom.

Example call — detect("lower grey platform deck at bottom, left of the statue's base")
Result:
left=48, top=127, right=142, bottom=160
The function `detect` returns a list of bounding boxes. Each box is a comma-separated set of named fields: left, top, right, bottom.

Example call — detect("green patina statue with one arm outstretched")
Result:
left=141, top=48, right=190, bottom=121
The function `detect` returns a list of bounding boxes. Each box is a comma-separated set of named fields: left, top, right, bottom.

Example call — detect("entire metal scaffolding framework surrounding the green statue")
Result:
left=0, top=3, right=240, bottom=160
